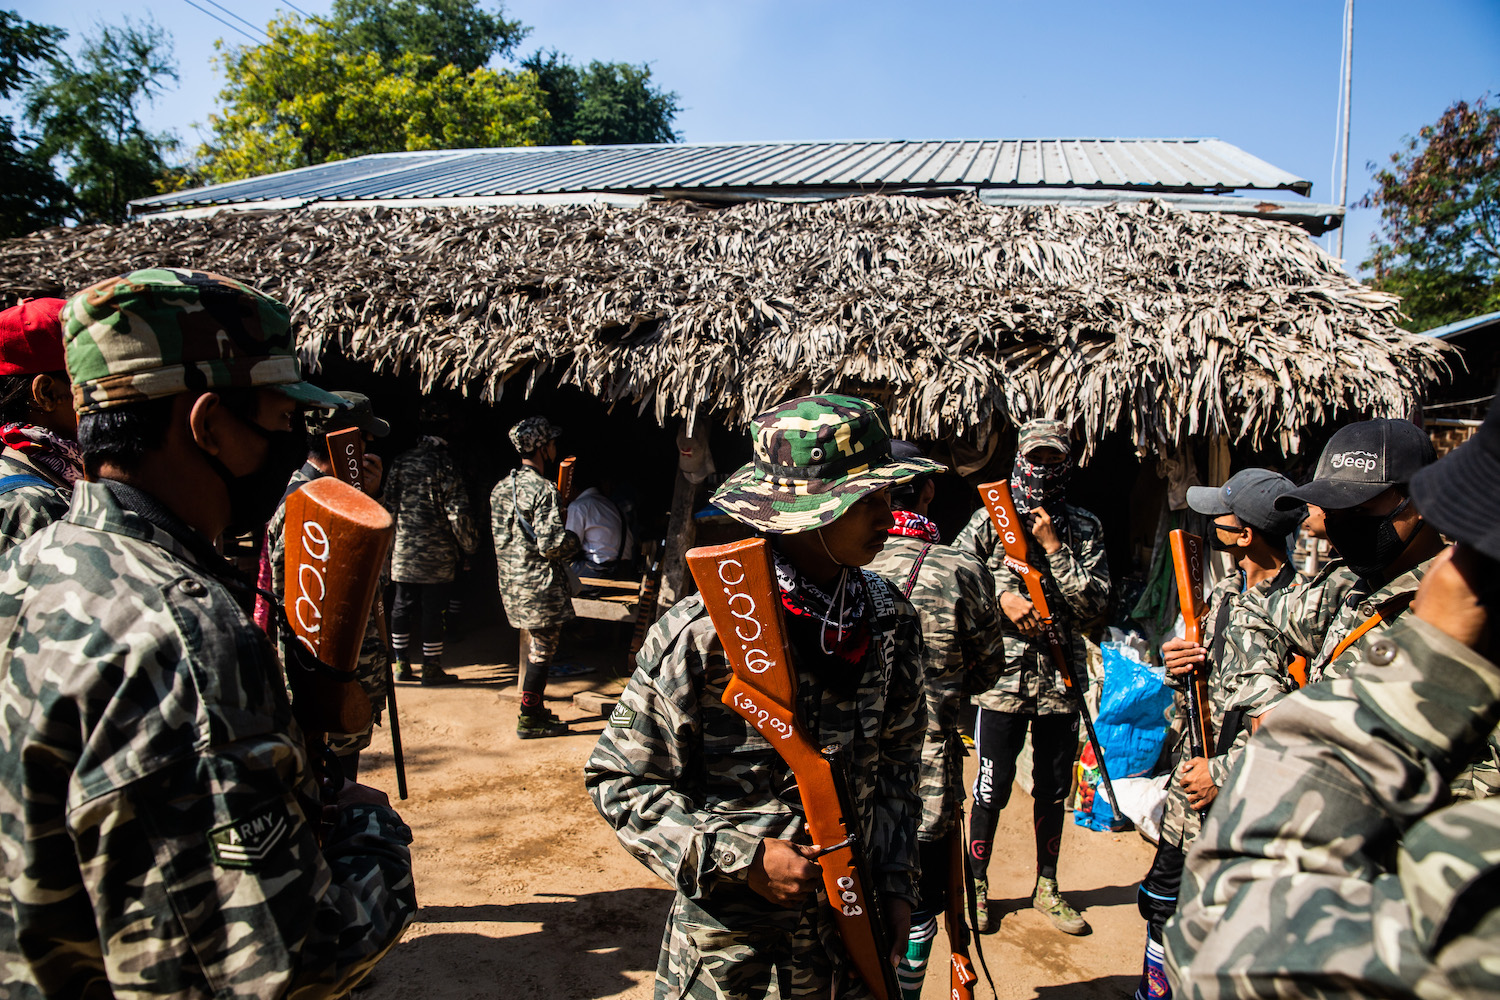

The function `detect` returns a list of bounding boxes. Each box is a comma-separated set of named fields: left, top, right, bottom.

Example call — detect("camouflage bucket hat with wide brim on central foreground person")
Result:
left=714, top=396, right=944, bottom=535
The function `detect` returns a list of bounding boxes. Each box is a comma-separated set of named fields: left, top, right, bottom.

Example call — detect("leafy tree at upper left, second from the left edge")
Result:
left=26, top=19, right=177, bottom=222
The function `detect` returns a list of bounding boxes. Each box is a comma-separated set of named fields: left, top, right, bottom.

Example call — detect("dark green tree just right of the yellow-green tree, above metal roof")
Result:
left=522, top=49, right=683, bottom=145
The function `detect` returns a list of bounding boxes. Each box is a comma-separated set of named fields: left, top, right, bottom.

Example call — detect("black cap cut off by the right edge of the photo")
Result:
left=1412, top=389, right=1500, bottom=559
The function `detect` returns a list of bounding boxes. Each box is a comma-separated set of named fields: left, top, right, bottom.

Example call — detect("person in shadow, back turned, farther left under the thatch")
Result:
left=383, top=399, right=479, bottom=685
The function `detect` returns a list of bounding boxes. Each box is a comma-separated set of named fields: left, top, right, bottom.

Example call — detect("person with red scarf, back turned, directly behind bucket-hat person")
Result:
left=867, top=441, right=1005, bottom=1000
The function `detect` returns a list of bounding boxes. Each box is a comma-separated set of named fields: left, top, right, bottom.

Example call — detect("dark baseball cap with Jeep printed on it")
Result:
left=1277, top=418, right=1437, bottom=510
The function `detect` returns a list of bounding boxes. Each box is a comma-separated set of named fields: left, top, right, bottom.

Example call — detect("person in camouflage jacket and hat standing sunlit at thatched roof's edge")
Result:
left=489, top=417, right=581, bottom=739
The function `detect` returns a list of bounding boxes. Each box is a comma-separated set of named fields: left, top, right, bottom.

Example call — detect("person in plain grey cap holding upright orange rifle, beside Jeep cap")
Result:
left=1136, top=469, right=1302, bottom=1000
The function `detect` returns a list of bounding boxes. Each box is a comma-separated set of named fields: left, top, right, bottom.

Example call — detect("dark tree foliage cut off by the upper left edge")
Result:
left=0, top=10, right=68, bottom=238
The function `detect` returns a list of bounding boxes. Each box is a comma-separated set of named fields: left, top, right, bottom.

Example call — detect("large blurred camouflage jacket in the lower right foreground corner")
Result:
left=1166, top=616, right=1500, bottom=999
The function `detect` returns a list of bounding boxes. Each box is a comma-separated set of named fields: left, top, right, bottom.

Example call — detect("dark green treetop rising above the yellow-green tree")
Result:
left=329, top=0, right=530, bottom=73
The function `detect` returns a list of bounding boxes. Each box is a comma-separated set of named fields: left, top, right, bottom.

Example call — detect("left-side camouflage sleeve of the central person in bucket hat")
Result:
left=584, top=605, right=774, bottom=900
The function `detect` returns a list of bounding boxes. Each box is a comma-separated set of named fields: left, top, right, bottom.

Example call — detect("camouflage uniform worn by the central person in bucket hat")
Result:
left=585, top=573, right=927, bottom=1000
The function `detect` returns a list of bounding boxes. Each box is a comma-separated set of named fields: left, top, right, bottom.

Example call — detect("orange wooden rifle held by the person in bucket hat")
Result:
left=687, top=538, right=902, bottom=1000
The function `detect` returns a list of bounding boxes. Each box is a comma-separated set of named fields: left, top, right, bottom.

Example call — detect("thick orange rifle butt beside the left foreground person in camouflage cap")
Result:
left=285, top=477, right=396, bottom=828
